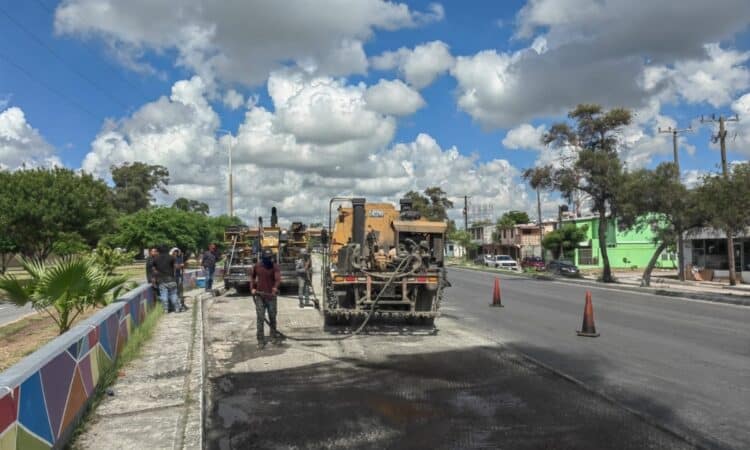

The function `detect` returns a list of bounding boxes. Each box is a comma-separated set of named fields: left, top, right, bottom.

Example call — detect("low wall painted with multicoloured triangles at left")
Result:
left=0, top=270, right=213, bottom=450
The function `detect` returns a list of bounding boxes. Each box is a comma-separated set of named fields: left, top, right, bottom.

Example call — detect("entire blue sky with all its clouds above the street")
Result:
left=0, top=0, right=750, bottom=222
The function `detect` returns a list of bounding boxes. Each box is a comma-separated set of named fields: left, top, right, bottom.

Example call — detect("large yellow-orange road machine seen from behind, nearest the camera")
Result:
left=322, top=198, right=449, bottom=325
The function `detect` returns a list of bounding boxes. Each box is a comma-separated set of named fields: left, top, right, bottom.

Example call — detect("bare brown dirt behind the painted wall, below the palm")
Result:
left=0, top=308, right=99, bottom=372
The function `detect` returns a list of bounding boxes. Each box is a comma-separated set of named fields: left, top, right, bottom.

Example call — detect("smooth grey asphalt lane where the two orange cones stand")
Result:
left=443, top=269, right=750, bottom=448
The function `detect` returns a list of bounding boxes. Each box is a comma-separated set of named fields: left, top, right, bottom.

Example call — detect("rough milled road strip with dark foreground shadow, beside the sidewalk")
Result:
left=204, top=286, right=691, bottom=449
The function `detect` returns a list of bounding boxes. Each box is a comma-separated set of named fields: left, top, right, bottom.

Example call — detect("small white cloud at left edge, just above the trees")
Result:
left=0, top=106, right=62, bottom=170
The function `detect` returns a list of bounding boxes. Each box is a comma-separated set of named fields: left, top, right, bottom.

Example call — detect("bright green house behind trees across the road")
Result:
left=563, top=217, right=677, bottom=269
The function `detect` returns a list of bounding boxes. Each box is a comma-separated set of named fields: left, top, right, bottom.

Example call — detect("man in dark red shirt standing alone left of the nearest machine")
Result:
left=250, top=249, right=281, bottom=349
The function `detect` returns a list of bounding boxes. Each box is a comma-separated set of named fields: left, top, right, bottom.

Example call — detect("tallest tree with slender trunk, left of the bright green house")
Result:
left=542, top=104, right=632, bottom=283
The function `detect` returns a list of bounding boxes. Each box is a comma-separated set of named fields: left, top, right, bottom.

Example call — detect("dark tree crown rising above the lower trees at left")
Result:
left=110, top=161, right=169, bottom=214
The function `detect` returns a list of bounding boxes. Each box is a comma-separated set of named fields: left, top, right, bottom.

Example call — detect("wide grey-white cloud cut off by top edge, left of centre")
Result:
left=55, top=0, right=444, bottom=86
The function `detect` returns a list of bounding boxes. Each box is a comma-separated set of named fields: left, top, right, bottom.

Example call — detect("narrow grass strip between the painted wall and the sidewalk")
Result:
left=65, top=304, right=164, bottom=449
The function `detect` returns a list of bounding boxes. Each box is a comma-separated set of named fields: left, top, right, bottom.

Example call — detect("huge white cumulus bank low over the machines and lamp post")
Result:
left=83, top=71, right=526, bottom=225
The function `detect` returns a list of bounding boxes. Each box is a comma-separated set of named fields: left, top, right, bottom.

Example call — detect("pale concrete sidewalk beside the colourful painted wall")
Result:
left=73, top=290, right=209, bottom=450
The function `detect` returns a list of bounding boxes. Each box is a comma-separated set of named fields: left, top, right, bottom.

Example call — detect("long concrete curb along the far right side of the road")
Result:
left=447, top=265, right=750, bottom=306
